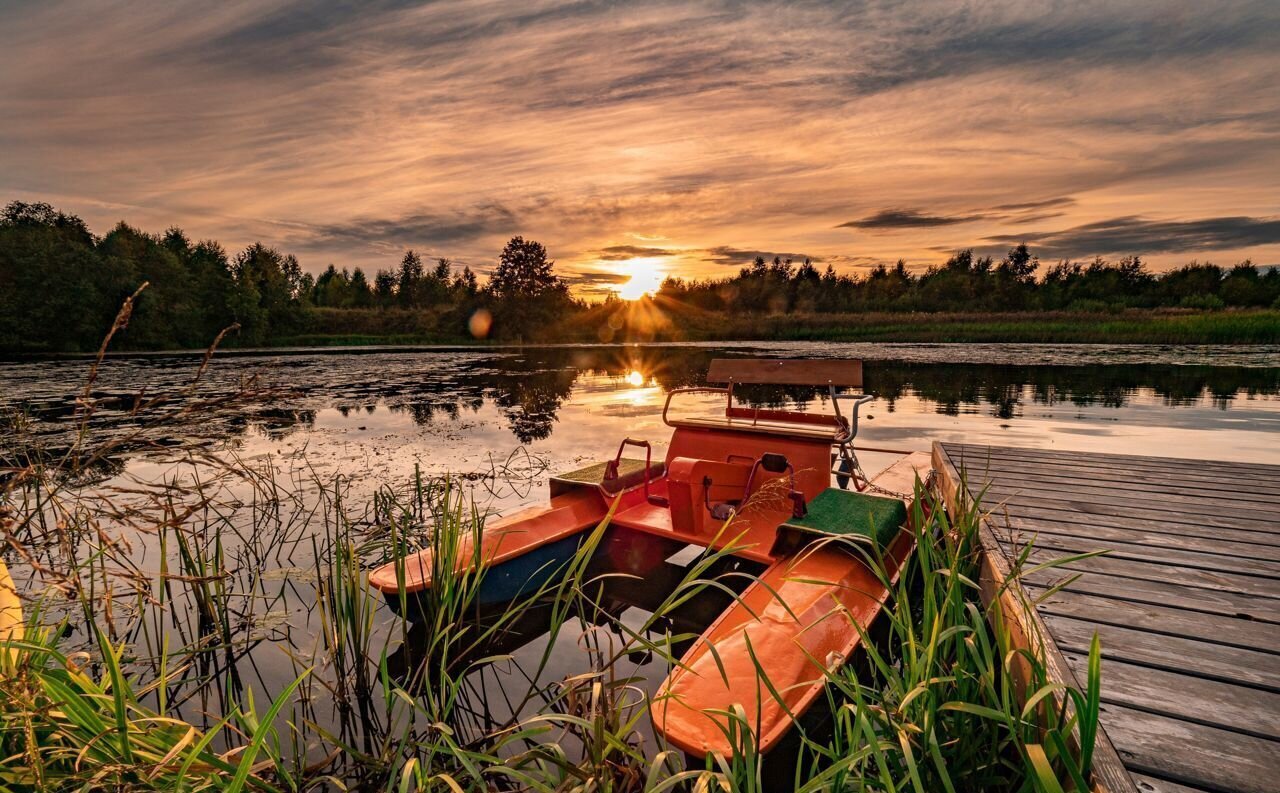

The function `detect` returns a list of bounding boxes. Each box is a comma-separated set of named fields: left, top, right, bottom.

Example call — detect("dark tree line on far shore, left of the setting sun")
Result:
left=0, top=201, right=570, bottom=352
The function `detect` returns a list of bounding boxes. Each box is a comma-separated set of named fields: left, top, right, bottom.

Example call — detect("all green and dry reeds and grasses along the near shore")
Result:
left=0, top=452, right=1097, bottom=790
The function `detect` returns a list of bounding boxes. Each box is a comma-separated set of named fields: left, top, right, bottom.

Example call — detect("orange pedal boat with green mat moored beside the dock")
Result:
left=369, top=359, right=929, bottom=756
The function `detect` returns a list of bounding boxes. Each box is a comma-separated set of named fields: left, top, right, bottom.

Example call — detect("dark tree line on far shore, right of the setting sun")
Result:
left=658, top=244, right=1280, bottom=313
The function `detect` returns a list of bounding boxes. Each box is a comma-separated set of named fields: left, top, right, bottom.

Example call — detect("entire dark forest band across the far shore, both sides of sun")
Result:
left=0, top=202, right=1280, bottom=352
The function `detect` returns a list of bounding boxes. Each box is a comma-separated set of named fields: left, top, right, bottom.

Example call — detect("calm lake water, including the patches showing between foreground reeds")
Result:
left=0, top=343, right=1280, bottom=772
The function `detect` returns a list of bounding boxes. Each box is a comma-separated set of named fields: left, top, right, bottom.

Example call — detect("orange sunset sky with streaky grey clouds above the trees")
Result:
left=0, top=0, right=1280, bottom=295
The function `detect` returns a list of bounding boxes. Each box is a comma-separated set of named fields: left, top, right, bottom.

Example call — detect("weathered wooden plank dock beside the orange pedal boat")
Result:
left=933, top=444, right=1280, bottom=793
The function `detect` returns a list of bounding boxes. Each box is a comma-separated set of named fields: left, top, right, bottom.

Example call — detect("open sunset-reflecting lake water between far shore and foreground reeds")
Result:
left=0, top=343, right=1280, bottom=483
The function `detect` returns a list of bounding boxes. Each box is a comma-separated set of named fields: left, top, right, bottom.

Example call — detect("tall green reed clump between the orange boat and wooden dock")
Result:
left=803, top=483, right=1101, bottom=793
